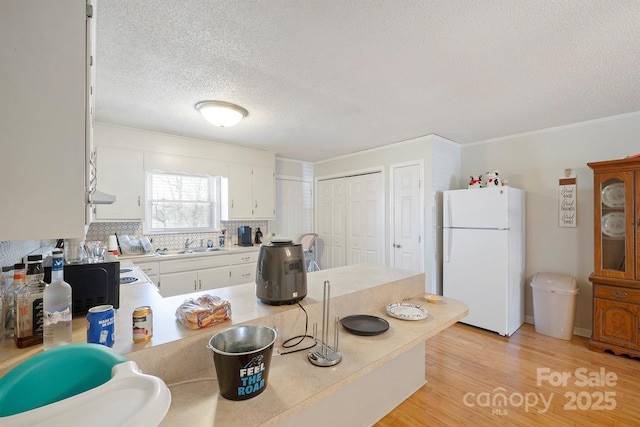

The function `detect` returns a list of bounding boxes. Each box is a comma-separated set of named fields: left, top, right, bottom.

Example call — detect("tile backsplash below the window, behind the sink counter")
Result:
left=87, top=221, right=268, bottom=251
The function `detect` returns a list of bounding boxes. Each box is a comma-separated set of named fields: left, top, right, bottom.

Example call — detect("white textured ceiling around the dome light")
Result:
left=95, top=0, right=640, bottom=161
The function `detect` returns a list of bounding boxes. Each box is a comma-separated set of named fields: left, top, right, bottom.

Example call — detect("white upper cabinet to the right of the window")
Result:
left=223, top=164, right=275, bottom=220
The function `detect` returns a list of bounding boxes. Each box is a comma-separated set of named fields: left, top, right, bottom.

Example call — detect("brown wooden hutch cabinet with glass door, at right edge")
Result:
left=588, top=158, right=640, bottom=357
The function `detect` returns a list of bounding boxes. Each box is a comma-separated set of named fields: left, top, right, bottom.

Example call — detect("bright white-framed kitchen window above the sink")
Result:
left=145, top=172, right=220, bottom=233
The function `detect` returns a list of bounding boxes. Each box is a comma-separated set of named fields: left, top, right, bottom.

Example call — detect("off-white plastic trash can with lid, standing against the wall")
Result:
left=531, top=273, right=578, bottom=340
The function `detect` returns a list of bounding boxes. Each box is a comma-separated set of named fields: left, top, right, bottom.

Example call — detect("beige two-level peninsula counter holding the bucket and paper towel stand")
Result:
left=0, top=264, right=468, bottom=427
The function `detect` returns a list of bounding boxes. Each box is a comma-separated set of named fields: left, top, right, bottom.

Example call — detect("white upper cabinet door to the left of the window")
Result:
left=96, top=146, right=144, bottom=221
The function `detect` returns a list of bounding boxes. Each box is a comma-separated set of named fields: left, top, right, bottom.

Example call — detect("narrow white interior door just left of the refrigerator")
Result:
left=390, top=164, right=424, bottom=271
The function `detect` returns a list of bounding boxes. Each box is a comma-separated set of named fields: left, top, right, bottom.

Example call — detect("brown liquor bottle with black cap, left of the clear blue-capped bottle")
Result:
left=14, top=255, right=46, bottom=348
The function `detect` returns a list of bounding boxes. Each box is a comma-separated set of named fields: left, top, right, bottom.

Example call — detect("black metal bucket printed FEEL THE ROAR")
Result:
left=207, top=325, right=277, bottom=400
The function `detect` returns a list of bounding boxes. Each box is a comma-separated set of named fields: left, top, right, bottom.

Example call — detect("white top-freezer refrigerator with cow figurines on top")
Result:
left=442, top=186, right=525, bottom=336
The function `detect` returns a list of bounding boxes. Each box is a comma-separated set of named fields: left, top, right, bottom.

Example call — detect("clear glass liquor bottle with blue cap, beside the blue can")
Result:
left=43, top=251, right=72, bottom=350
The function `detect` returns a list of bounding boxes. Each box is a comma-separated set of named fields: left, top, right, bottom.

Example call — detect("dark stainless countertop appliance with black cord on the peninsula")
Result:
left=256, top=239, right=307, bottom=305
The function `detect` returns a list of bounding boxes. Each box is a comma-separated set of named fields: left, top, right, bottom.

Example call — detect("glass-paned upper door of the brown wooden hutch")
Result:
left=594, top=172, right=636, bottom=279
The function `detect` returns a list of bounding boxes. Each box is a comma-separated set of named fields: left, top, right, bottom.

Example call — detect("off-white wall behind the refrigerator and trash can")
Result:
left=459, top=113, right=640, bottom=336
